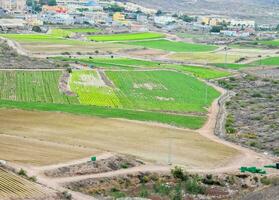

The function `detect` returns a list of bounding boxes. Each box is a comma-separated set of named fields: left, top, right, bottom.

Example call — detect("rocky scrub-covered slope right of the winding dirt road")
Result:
left=219, top=74, right=279, bottom=156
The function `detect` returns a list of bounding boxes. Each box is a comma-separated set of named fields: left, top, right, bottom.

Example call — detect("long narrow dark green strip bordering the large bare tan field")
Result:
left=0, top=100, right=206, bottom=129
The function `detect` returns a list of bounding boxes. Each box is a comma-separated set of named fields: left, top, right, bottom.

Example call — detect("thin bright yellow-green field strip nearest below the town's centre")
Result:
left=88, top=32, right=165, bottom=42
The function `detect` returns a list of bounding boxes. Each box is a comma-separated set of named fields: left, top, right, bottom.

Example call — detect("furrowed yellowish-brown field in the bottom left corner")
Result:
left=0, top=168, right=46, bottom=200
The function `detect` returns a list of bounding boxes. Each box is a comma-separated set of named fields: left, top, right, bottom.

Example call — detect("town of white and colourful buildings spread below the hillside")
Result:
left=0, top=0, right=276, bottom=37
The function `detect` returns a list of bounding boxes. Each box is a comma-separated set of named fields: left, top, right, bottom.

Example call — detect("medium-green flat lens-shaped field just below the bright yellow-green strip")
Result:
left=125, top=39, right=218, bottom=52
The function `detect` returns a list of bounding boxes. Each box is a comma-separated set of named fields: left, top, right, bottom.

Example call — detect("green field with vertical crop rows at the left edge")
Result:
left=0, top=71, right=78, bottom=104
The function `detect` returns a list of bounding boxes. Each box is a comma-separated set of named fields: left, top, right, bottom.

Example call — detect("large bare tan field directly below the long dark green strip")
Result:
left=0, top=110, right=239, bottom=169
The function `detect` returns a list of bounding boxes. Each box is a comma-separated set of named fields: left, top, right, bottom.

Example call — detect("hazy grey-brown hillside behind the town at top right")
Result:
left=119, top=0, right=279, bottom=24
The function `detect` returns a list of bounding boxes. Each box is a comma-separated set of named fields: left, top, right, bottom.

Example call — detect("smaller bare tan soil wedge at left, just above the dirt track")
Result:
left=0, top=134, right=98, bottom=165
